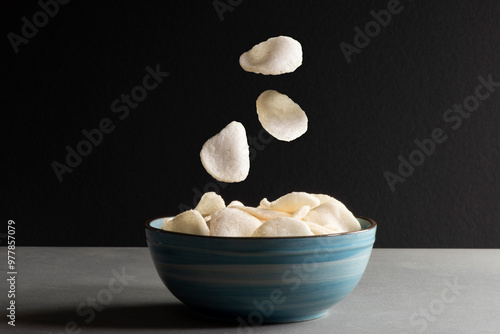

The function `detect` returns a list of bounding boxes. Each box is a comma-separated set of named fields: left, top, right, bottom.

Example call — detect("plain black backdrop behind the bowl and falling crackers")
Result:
left=1, top=0, right=500, bottom=247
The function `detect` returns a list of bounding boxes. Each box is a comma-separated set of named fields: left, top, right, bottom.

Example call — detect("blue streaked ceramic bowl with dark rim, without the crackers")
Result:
left=146, top=217, right=377, bottom=325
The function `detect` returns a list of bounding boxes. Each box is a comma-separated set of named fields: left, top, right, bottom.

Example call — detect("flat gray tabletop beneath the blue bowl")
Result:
left=0, top=247, right=500, bottom=334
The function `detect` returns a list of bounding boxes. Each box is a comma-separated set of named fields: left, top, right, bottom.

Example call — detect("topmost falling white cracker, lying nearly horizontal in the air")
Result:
left=240, top=36, right=302, bottom=75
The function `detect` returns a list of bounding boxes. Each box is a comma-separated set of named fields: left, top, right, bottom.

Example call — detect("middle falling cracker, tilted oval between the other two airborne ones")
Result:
left=257, top=90, right=308, bottom=142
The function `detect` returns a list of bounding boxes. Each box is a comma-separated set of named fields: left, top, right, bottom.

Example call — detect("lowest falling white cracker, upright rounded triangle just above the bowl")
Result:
left=200, top=121, right=250, bottom=183
